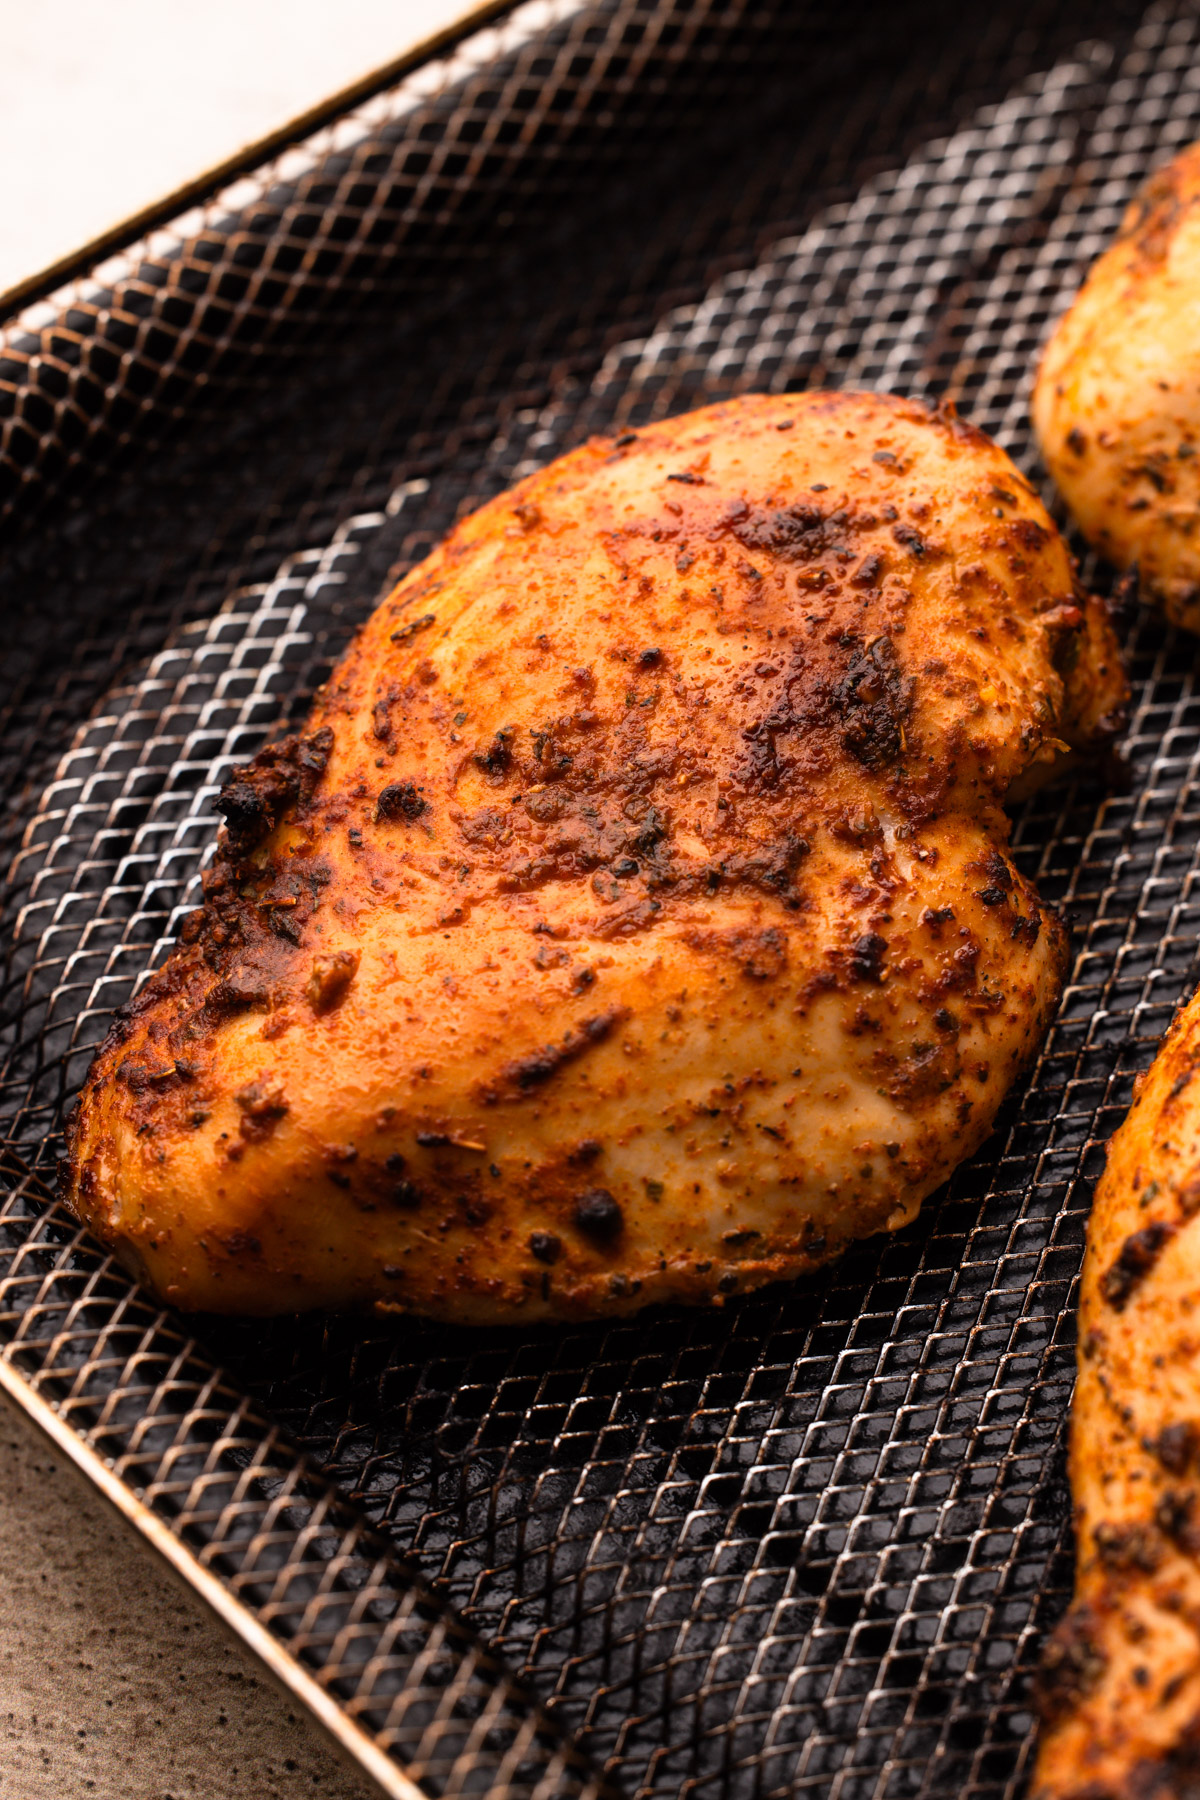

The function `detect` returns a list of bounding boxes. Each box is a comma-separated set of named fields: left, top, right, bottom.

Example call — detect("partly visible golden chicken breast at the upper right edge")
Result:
left=1033, top=144, right=1200, bottom=632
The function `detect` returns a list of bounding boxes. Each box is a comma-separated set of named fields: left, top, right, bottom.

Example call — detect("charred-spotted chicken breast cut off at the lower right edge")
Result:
left=1033, top=997, right=1200, bottom=1800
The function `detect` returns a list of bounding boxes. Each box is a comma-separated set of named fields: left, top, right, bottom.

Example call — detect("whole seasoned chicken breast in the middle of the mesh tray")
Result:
left=68, top=394, right=1124, bottom=1319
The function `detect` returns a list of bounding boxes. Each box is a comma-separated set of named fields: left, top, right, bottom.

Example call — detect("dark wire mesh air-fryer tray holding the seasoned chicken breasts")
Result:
left=0, top=0, right=1200, bottom=1800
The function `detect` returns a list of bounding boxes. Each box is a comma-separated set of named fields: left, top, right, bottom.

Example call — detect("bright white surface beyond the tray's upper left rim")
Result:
left=0, top=0, right=470, bottom=295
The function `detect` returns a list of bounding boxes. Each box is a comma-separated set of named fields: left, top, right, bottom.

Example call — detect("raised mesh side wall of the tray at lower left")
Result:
left=0, top=1166, right=604, bottom=1800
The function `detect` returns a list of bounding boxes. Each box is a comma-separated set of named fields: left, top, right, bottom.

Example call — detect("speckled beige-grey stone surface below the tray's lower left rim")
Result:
left=0, top=1399, right=378, bottom=1800
